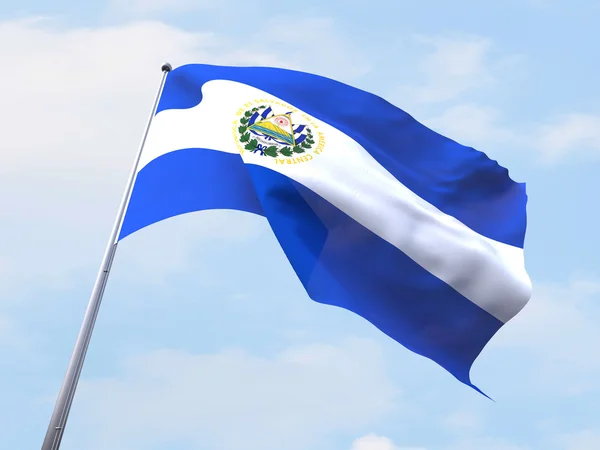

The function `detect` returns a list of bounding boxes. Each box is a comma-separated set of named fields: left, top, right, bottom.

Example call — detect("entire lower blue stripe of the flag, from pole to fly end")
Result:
left=121, top=149, right=502, bottom=386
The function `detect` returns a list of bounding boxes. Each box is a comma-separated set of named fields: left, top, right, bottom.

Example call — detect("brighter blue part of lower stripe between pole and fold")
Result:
left=119, top=149, right=264, bottom=239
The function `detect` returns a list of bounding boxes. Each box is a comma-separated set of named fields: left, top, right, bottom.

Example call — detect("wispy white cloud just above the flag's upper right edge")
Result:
left=400, top=36, right=528, bottom=170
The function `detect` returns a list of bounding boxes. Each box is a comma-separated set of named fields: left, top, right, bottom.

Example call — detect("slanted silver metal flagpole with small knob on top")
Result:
left=42, top=63, right=171, bottom=450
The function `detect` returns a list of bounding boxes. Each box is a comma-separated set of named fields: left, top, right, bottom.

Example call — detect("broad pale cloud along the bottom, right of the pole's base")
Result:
left=64, top=339, right=398, bottom=450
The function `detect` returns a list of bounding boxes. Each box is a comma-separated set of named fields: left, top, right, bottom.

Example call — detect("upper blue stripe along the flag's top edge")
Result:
left=158, top=64, right=527, bottom=247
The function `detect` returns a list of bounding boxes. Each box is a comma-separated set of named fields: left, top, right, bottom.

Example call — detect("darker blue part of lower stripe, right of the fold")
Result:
left=244, top=165, right=502, bottom=386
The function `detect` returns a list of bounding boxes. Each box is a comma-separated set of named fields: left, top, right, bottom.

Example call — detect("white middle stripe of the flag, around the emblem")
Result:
left=140, top=80, right=531, bottom=322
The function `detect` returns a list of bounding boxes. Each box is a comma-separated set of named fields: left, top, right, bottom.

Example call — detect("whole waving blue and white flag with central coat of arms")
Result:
left=119, top=64, right=531, bottom=394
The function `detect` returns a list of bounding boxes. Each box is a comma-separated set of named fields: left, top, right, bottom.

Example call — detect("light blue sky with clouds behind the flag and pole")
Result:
left=0, top=0, right=600, bottom=450
